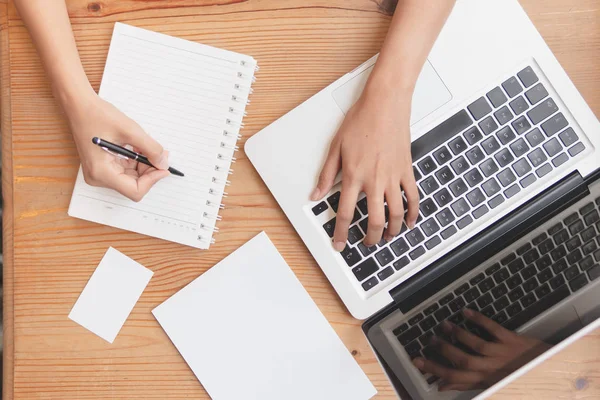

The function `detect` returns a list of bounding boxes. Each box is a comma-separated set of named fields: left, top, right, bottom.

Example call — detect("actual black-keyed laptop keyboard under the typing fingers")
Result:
left=312, top=67, right=586, bottom=292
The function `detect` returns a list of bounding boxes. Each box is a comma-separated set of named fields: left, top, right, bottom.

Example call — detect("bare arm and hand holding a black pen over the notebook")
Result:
left=15, top=0, right=169, bottom=201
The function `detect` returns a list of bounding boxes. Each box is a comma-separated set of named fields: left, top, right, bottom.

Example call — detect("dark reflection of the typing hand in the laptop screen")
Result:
left=413, top=310, right=550, bottom=391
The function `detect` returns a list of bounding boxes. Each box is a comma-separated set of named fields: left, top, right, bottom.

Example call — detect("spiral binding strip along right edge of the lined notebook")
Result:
left=198, top=57, right=259, bottom=244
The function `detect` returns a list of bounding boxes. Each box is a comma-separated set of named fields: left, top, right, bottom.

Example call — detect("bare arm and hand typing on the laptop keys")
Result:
left=311, top=0, right=455, bottom=251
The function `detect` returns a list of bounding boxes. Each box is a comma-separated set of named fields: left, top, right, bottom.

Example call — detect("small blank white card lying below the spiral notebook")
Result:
left=69, top=247, right=154, bottom=343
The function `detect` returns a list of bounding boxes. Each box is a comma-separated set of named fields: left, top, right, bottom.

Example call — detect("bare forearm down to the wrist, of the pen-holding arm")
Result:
left=15, top=0, right=93, bottom=113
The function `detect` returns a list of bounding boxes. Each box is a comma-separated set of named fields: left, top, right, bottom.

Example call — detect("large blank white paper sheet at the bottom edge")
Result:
left=153, top=233, right=377, bottom=400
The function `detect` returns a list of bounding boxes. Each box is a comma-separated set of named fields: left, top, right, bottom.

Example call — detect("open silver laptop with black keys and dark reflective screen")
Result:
left=245, top=0, right=600, bottom=398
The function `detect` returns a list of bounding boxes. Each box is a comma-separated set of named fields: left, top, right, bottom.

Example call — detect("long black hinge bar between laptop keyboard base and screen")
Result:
left=389, top=171, right=589, bottom=312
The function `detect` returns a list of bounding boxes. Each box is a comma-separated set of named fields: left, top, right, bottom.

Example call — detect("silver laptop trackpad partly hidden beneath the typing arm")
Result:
left=333, top=60, right=452, bottom=125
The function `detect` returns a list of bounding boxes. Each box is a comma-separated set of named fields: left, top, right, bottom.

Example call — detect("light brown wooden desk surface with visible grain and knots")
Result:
left=0, top=0, right=600, bottom=400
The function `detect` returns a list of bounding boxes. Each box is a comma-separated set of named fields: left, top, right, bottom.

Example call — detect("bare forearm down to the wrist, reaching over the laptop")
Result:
left=367, top=0, right=455, bottom=96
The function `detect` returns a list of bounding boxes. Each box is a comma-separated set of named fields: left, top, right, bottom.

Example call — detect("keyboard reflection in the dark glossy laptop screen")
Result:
left=393, top=197, right=600, bottom=384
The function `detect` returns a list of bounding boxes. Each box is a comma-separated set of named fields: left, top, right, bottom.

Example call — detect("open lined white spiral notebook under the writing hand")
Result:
left=69, top=23, right=257, bottom=249
